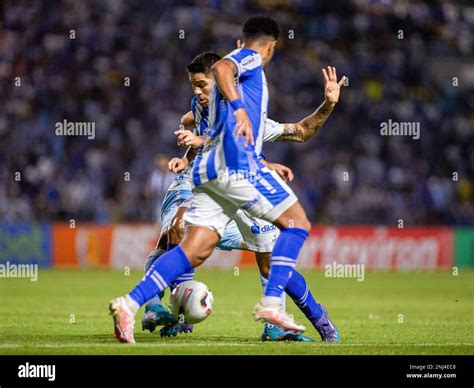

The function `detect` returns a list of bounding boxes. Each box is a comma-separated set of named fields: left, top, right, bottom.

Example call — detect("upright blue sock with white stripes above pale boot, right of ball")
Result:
left=265, top=228, right=309, bottom=297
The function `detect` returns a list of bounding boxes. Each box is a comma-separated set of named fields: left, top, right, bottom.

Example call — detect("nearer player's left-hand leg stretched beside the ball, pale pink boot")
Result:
left=109, top=185, right=231, bottom=343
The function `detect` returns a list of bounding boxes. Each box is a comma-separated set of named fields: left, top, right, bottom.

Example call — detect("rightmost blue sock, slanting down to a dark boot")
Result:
left=285, top=270, right=323, bottom=325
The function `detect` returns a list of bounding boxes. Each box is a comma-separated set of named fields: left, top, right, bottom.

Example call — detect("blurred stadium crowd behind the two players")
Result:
left=0, top=0, right=474, bottom=225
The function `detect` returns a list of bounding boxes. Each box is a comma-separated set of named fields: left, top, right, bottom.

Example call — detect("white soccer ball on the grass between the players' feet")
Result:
left=169, top=280, right=214, bottom=324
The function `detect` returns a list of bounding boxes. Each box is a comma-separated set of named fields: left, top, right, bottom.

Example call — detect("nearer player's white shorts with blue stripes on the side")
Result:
left=184, top=167, right=298, bottom=236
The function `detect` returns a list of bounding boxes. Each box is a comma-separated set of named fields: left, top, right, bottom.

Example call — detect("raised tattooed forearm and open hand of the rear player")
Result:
left=275, top=66, right=346, bottom=142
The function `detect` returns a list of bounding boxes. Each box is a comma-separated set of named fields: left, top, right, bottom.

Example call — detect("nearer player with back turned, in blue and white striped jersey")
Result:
left=110, top=17, right=342, bottom=343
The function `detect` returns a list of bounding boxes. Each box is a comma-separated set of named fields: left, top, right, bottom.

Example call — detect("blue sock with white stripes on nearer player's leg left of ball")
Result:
left=129, top=247, right=192, bottom=306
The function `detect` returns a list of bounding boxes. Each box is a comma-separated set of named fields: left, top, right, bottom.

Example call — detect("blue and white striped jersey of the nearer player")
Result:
left=193, top=48, right=268, bottom=186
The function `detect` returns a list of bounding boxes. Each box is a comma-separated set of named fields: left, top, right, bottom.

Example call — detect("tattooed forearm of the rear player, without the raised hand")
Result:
left=275, top=102, right=334, bottom=142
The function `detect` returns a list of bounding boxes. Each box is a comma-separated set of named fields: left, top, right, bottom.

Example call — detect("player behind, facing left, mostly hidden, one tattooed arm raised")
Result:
left=142, top=52, right=339, bottom=341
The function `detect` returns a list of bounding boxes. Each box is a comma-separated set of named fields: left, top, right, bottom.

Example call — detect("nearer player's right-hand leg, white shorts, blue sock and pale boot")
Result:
left=213, top=167, right=311, bottom=332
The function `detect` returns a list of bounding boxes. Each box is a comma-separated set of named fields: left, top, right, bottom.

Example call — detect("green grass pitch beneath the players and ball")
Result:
left=0, top=269, right=474, bottom=355
